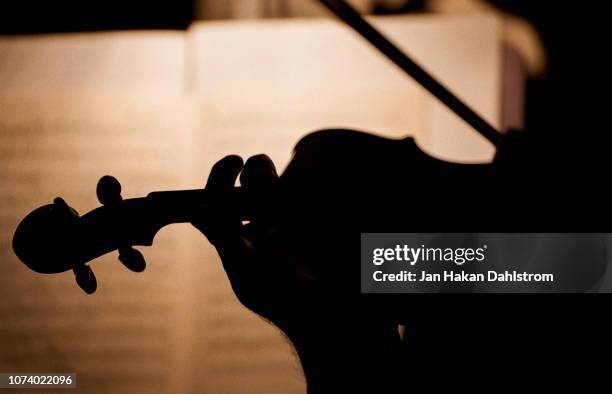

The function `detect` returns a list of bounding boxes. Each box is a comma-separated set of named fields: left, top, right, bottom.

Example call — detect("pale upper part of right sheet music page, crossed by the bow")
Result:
left=188, top=15, right=502, bottom=168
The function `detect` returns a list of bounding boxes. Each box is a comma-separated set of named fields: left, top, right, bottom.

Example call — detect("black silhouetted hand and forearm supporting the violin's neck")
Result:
left=193, top=155, right=399, bottom=391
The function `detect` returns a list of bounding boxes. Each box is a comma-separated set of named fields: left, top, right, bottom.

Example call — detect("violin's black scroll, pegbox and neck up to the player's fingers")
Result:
left=13, top=175, right=253, bottom=294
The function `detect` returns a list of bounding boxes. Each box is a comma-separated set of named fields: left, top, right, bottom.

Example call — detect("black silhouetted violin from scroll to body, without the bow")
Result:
left=13, top=130, right=506, bottom=294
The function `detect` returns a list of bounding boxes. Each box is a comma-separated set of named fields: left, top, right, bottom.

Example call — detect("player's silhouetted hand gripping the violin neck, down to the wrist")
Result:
left=193, top=155, right=320, bottom=335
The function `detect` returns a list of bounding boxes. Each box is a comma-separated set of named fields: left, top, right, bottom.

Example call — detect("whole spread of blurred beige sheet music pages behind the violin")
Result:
left=0, top=13, right=501, bottom=393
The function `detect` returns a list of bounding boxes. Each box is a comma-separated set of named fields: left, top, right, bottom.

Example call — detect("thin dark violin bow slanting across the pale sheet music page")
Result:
left=320, top=0, right=503, bottom=147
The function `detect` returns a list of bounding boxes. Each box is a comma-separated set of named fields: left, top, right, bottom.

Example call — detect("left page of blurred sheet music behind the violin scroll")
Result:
left=0, top=94, right=198, bottom=393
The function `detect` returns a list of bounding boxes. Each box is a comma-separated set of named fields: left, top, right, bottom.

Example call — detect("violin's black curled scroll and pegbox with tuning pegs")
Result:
left=13, top=175, right=153, bottom=294
